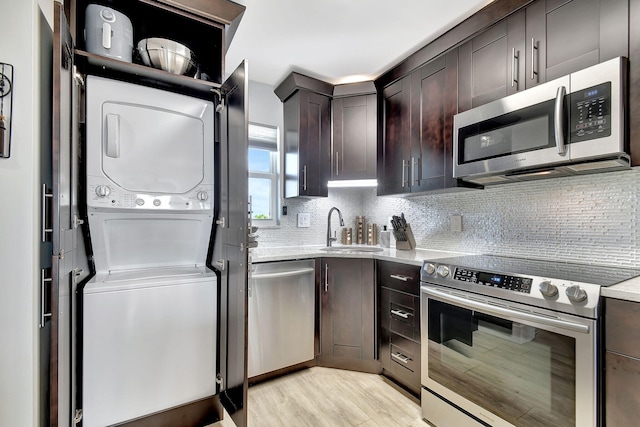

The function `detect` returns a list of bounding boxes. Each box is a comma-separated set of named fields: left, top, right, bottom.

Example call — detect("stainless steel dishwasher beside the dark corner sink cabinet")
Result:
left=248, top=259, right=315, bottom=378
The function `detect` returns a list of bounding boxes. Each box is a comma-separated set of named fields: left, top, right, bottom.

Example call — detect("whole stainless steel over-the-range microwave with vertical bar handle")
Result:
left=453, top=57, right=630, bottom=185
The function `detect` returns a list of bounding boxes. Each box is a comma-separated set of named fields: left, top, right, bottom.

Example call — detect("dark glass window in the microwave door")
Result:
left=458, top=100, right=555, bottom=163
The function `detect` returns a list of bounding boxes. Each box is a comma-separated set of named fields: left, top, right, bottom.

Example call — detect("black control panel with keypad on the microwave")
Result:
left=569, top=82, right=611, bottom=142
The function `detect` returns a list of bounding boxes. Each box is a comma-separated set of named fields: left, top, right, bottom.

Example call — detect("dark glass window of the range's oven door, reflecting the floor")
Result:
left=427, top=299, right=576, bottom=427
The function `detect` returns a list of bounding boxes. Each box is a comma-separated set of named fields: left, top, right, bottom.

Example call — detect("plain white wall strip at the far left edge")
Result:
left=0, top=0, right=53, bottom=426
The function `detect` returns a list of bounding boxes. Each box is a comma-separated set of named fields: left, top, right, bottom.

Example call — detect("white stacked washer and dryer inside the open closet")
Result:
left=82, top=76, right=218, bottom=427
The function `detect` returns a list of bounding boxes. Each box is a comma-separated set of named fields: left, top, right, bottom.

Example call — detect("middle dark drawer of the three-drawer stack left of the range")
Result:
left=380, top=287, right=420, bottom=341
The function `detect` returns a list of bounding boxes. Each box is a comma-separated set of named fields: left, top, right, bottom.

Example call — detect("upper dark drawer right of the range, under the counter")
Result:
left=605, top=298, right=640, bottom=358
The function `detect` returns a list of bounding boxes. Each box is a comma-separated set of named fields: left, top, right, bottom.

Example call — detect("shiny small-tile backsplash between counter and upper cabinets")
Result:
left=259, top=169, right=640, bottom=268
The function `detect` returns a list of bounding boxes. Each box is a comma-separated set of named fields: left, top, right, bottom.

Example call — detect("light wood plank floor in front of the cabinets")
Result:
left=216, top=367, right=428, bottom=427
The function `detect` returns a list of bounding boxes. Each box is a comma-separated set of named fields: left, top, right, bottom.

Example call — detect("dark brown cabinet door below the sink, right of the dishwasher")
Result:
left=317, top=258, right=377, bottom=371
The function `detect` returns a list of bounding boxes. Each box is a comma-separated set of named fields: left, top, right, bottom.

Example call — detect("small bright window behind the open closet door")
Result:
left=249, top=123, right=279, bottom=227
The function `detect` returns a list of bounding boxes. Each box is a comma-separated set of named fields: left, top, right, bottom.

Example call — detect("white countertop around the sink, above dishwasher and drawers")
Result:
left=250, top=245, right=465, bottom=266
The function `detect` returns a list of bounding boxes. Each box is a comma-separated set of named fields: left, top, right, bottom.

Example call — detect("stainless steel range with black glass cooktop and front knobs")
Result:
left=421, top=255, right=640, bottom=427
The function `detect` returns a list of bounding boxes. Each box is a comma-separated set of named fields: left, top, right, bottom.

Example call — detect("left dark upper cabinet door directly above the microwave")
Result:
left=459, top=11, right=525, bottom=111
